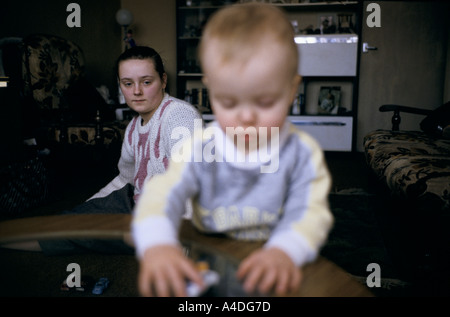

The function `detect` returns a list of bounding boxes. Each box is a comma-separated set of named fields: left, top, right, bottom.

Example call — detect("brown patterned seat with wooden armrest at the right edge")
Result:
left=364, top=102, right=450, bottom=286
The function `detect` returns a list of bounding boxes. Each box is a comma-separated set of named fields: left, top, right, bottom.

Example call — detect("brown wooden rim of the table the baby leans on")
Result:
left=0, top=214, right=373, bottom=297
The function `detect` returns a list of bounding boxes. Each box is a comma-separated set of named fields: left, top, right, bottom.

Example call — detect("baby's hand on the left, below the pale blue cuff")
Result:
left=138, top=245, right=203, bottom=297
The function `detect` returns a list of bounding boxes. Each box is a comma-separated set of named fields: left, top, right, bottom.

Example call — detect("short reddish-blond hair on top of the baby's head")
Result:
left=198, top=3, right=298, bottom=73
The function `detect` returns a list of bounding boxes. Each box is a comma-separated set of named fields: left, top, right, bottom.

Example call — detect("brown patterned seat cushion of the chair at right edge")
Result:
left=364, top=130, right=450, bottom=210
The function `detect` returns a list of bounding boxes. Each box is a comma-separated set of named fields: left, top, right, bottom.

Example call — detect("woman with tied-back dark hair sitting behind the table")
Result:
left=4, top=46, right=201, bottom=254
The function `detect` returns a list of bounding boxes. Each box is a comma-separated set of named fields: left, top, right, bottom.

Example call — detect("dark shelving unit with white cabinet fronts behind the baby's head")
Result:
left=176, top=0, right=362, bottom=151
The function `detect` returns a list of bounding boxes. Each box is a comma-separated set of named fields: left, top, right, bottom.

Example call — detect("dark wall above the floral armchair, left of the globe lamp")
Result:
left=0, top=0, right=122, bottom=100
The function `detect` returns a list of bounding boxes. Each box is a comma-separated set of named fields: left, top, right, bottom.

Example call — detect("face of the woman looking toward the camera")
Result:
left=119, top=59, right=167, bottom=124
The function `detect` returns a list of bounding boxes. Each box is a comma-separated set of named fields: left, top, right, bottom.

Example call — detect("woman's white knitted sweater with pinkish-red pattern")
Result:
left=89, top=93, right=201, bottom=201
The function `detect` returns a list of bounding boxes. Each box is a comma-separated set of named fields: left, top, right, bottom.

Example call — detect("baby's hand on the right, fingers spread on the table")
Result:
left=237, top=248, right=302, bottom=296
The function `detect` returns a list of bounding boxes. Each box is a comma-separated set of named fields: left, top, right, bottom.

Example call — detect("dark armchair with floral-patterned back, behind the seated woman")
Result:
left=22, top=34, right=123, bottom=150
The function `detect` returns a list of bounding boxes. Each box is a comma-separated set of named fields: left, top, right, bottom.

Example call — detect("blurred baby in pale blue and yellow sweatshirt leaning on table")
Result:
left=132, top=4, right=333, bottom=296
